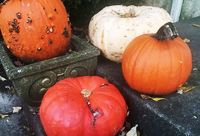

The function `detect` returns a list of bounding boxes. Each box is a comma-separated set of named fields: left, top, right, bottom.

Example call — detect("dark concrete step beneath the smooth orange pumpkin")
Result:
left=96, top=17, right=200, bottom=136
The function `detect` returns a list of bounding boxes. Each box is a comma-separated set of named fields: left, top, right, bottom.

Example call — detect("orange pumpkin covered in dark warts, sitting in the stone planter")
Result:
left=0, top=0, right=71, bottom=63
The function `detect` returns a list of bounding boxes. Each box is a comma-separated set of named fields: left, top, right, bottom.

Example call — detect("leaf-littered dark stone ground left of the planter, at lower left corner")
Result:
left=0, top=64, right=32, bottom=136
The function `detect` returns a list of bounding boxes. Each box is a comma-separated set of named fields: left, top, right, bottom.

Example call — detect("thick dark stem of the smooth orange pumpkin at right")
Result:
left=151, top=22, right=178, bottom=41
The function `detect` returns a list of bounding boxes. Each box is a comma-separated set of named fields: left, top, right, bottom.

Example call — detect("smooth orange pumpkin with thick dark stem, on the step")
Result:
left=122, top=23, right=192, bottom=95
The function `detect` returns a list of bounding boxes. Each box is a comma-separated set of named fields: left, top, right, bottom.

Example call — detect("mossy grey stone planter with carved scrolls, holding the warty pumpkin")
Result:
left=0, top=35, right=100, bottom=106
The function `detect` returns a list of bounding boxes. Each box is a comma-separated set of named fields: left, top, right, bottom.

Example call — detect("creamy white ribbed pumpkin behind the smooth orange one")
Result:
left=89, top=5, right=172, bottom=62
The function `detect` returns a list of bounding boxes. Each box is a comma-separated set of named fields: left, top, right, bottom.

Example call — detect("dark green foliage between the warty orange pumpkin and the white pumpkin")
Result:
left=62, top=0, right=141, bottom=26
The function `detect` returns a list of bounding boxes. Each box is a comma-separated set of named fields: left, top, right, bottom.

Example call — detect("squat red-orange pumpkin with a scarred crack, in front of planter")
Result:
left=39, top=76, right=127, bottom=136
